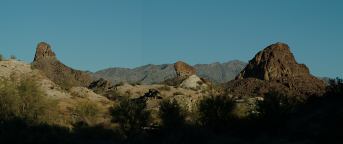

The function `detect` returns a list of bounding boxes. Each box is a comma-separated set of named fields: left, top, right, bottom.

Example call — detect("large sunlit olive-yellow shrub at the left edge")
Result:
left=0, top=75, right=56, bottom=123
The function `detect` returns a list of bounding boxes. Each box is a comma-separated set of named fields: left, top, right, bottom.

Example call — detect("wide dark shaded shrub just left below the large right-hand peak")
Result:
left=198, top=96, right=235, bottom=130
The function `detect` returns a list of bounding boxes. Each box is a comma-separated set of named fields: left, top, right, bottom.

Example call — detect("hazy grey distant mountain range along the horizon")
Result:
left=92, top=60, right=246, bottom=84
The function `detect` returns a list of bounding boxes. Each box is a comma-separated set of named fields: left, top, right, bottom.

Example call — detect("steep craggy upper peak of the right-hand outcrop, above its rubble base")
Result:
left=236, top=43, right=310, bottom=81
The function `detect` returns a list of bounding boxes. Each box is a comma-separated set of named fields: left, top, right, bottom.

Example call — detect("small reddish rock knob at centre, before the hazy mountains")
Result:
left=174, top=61, right=196, bottom=77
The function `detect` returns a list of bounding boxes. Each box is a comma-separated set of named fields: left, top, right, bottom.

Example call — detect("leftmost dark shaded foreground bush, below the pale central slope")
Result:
left=111, top=99, right=150, bottom=135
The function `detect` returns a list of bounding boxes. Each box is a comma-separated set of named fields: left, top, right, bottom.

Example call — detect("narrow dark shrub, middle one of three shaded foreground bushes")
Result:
left=159, top=99, right=185, bottom=129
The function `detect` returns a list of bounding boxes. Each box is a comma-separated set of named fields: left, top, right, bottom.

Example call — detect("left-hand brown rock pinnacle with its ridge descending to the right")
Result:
left=32, top=42, right=91, bottom=88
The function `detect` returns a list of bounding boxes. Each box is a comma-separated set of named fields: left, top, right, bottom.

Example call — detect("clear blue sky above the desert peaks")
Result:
left=0, top=0, right=343, bottom=77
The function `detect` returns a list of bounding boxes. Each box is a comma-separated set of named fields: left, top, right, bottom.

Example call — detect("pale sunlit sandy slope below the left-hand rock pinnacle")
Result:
left=0, top=59, right=114, bottom=126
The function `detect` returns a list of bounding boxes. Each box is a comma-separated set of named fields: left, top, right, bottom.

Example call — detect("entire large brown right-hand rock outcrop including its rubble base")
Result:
left=227, top=43, right=325, bottom=96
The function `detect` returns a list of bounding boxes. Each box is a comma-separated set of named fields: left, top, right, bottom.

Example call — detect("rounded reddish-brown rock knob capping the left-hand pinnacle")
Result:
left=34, top=42, right=56, bottom=61
